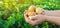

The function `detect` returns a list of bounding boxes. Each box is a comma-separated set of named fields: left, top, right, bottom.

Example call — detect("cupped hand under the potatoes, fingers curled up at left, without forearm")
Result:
left=24, top=10, right=45, bottom=26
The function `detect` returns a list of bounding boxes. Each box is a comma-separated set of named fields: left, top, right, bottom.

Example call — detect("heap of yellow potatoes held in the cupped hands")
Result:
left=28, top=6, right=44, bottom=19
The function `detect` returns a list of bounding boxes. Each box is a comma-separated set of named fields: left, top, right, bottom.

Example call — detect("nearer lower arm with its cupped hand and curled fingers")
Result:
left=24, top=9, right=60, bottom=25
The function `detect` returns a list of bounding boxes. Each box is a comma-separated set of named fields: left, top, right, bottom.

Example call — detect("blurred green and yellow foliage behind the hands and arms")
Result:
left=0, top=0, right=60, bottom=28
